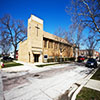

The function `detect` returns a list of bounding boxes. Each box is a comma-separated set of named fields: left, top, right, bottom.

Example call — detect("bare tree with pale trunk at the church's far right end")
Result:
left=66, top=21, right=84, bottom=58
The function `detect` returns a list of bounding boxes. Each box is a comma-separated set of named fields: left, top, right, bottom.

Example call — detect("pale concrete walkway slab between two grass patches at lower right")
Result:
left=84, top=79, right=100, bottom=91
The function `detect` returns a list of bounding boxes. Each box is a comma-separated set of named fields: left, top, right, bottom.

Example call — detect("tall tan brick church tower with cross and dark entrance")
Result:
left=28, top=15, right=43, bottom=62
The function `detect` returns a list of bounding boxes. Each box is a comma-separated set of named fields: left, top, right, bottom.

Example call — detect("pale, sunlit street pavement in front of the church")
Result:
left=2, top=63, right=92, bottom=100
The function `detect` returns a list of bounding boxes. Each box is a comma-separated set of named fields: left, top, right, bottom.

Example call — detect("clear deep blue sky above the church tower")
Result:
left=0, top=0, right=71, bottom=34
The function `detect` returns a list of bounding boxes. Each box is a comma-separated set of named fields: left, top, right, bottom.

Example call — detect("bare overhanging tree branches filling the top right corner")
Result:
left=66, top=0, right=100, bottom=37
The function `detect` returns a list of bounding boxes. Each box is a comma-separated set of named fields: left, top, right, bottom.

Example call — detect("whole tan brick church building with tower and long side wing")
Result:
left=18, top=15, right=73, bottom=63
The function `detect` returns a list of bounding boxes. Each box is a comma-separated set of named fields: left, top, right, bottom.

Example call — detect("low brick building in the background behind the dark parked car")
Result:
left=79, top=49, right=99, bottom=58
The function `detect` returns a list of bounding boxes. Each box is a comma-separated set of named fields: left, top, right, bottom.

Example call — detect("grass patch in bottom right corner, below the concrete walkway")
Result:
left=76, top=87, right=100, bottom=100
